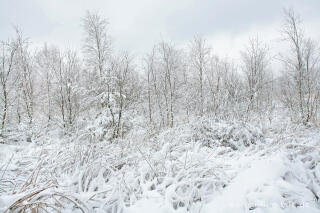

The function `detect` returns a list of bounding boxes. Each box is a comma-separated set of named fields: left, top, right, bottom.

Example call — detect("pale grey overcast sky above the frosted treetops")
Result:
left=0, top=0, right=320, bottom=61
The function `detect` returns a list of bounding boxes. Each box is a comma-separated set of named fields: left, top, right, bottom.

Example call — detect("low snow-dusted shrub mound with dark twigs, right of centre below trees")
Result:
left=160, top=118, right=265, bottom=150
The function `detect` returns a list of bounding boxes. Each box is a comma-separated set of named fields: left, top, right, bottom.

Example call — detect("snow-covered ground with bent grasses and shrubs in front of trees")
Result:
left=0, top=118, right=320, bottom=213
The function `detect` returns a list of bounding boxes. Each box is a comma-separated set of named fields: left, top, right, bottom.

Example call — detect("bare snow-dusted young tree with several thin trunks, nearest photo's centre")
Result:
left=145, top=42, right=185, bottom=128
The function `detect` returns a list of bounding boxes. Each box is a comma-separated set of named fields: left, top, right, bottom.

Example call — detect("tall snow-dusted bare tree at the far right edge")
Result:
left=282, top=10, right=319, bottom=123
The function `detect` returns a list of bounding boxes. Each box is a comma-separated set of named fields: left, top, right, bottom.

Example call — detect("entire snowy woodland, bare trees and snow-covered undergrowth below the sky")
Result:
left=0, top=6, right=320, bottom=213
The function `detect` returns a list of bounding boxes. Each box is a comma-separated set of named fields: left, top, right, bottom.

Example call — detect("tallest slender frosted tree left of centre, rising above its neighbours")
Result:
left=83, top=12, right=114, bottom=123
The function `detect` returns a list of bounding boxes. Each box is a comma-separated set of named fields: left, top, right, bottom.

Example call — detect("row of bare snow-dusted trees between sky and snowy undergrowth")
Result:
left=0, top=10, right=320, bottom=138
